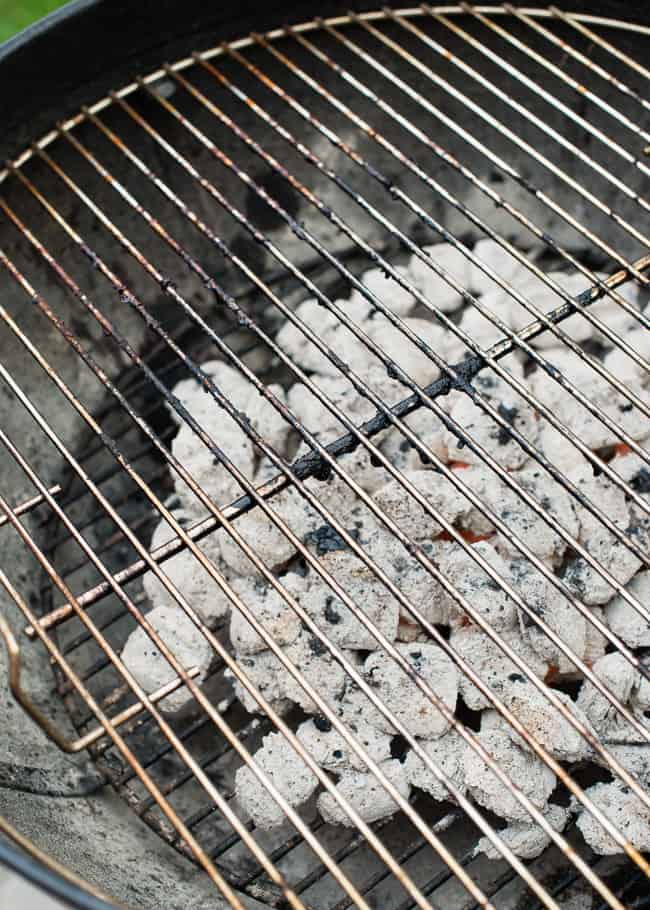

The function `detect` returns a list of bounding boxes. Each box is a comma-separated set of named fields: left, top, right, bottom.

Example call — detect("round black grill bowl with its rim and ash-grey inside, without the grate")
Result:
left=0, top=0, right=650, bottom=910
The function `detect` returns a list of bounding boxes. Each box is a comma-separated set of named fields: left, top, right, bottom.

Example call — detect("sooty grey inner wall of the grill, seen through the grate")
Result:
left=0, top=8, right=645, bottom=907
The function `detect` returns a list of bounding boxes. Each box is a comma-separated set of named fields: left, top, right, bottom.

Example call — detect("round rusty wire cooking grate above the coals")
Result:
left=0, top=5, right=650, bottom=910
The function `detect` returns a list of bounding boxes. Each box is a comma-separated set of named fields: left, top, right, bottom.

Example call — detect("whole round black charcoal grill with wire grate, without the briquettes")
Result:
left=0, top=2, right=650, bottom=910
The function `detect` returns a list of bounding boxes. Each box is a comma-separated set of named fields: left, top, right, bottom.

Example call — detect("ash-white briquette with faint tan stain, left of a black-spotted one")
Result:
left=230, top=573, right=306, bottom=655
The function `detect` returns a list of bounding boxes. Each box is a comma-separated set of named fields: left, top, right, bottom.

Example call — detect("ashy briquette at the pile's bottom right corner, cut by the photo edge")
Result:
left=577, top=781, right=650, bottom=856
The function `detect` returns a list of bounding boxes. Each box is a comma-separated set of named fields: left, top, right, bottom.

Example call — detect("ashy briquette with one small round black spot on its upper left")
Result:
left=296, top=717, right=392, bottom=773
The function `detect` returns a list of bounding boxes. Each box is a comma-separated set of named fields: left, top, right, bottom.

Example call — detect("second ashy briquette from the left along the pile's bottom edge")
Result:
left=318, top=760, right=410, bottom=828
